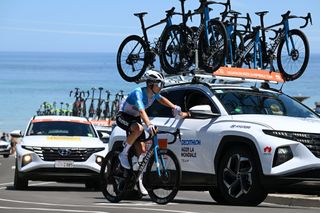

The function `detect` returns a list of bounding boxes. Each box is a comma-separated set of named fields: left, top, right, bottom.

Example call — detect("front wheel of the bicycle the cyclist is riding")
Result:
left=143, top=149, right=181, bottom=204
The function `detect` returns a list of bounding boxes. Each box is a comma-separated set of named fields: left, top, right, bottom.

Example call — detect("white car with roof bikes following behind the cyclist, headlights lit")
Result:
left=14, top=116, right=108, bottom=189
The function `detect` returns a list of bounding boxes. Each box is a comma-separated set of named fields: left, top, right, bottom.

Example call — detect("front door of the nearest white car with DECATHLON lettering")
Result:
left=147, top=88, right=217, bottom=174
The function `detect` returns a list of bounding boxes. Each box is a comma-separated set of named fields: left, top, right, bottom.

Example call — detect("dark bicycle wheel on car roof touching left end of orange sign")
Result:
left=199, top=19, right=228, bottom=73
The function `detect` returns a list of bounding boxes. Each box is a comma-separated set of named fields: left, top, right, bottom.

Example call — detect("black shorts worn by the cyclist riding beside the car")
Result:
left=116, top=112, right=146, bottom=141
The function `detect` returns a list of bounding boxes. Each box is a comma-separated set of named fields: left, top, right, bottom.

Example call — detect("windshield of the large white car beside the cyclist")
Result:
left=213, top=89, right=319, bottom=118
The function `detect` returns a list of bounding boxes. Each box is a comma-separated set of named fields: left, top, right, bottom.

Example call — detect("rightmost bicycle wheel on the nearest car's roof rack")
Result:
left=277, top=30, right=310, bottom=81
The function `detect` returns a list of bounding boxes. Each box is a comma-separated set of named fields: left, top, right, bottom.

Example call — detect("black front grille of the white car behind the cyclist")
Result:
left=23, top=146, right=104, bottom=162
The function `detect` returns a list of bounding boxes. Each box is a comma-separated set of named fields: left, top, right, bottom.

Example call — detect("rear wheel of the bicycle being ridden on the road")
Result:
left=100, top=151, right=124, bottom=203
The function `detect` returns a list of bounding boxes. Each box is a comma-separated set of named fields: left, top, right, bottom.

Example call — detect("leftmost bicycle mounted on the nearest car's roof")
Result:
left=117, top=7, right=176, bottom=82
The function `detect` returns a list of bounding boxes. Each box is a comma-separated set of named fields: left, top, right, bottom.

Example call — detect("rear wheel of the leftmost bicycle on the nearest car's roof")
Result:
left=117, top=35, right=147, bottom=82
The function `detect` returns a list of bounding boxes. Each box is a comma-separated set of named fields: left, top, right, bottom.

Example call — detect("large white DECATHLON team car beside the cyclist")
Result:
left=109, top=79, right=320, bottom=205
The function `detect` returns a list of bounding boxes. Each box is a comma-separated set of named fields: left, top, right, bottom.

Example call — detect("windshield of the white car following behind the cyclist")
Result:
left=27, top=121, right=97, bottom=137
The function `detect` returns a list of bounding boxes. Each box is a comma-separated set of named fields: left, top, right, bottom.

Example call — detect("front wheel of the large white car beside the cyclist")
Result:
left=217, top=146, right=267, bottom=206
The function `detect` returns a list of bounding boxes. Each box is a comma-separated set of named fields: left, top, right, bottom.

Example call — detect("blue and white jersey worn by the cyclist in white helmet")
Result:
left=120, top=87, right=162, bottom=117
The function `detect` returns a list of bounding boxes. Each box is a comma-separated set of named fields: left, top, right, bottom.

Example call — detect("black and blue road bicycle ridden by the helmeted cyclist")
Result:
left=100, top=127, right=181, bottom=204
